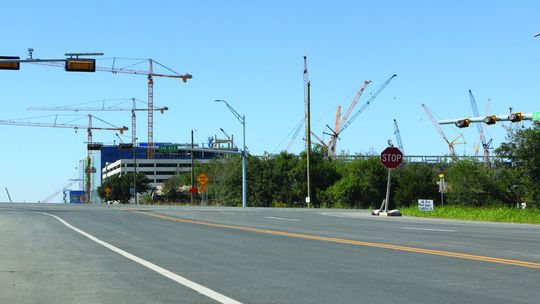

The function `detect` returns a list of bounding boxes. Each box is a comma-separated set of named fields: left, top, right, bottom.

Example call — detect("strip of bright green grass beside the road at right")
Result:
left=400, top=206, right=540, bottom=224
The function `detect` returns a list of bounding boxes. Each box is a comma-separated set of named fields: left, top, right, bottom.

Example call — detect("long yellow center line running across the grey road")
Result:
left=131, top=210, right=540, bottom=269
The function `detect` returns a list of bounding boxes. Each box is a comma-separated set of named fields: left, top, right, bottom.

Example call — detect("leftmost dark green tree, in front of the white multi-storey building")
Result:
left=97, top=173, right=150, bottom=204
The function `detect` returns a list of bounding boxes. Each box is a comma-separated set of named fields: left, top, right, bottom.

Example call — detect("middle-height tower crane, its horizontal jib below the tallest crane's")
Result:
left=28, top=98, right=169, bottom=147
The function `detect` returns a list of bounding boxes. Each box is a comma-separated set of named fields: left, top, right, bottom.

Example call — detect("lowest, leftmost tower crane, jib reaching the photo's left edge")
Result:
left=0, top=114, right=128, bottom=203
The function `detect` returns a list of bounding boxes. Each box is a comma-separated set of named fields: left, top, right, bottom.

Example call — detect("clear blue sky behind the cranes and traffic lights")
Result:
left=0, top=0, right=540, bottom=201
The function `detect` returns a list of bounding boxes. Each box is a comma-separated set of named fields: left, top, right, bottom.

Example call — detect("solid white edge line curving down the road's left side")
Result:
left=38, top=212, right=242, bottom=304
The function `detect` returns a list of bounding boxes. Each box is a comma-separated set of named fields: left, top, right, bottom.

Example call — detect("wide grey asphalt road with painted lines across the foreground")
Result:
left=0, top=204, right=540, bottom=303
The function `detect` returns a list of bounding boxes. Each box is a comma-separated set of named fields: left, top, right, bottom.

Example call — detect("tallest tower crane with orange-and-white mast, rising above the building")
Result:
left=31, top=55, right=193, bottom=159
